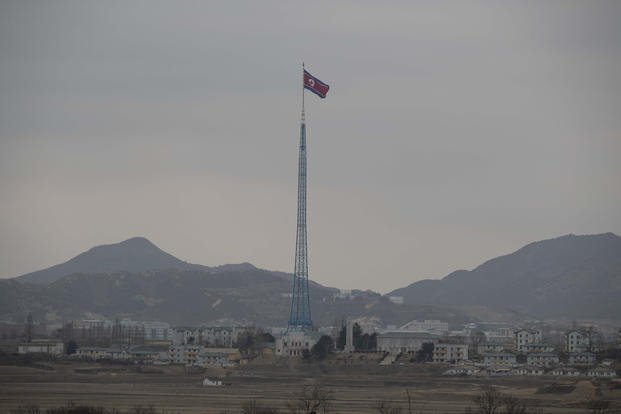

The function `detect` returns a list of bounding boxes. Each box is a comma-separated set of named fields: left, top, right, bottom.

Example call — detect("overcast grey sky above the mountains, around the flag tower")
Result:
left=0, top=0, right=621, bottom=292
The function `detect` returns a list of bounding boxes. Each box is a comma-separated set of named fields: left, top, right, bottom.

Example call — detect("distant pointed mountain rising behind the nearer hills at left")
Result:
left=16, top=237, right=209, bottom=284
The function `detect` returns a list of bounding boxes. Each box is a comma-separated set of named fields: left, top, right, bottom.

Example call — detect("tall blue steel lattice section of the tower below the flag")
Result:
left=289, top=111, right=313, bottom=330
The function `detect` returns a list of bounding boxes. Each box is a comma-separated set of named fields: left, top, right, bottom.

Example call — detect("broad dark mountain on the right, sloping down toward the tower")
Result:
left=387, top=233, right=621, bottom=319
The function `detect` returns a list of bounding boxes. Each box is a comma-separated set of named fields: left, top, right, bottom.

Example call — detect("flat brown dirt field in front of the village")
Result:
left=0, top=362, right=621, bottom=413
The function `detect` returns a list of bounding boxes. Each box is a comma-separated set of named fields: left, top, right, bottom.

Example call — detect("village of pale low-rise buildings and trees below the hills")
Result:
left=0, top=319, right=621, bottom=378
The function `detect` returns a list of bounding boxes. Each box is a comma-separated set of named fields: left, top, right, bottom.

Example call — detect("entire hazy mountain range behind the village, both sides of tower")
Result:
left=0, top=233, right=621, bottom=326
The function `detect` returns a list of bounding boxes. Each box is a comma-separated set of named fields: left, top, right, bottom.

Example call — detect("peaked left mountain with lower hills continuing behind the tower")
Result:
left=0, top=238, right=473, bottom=326
